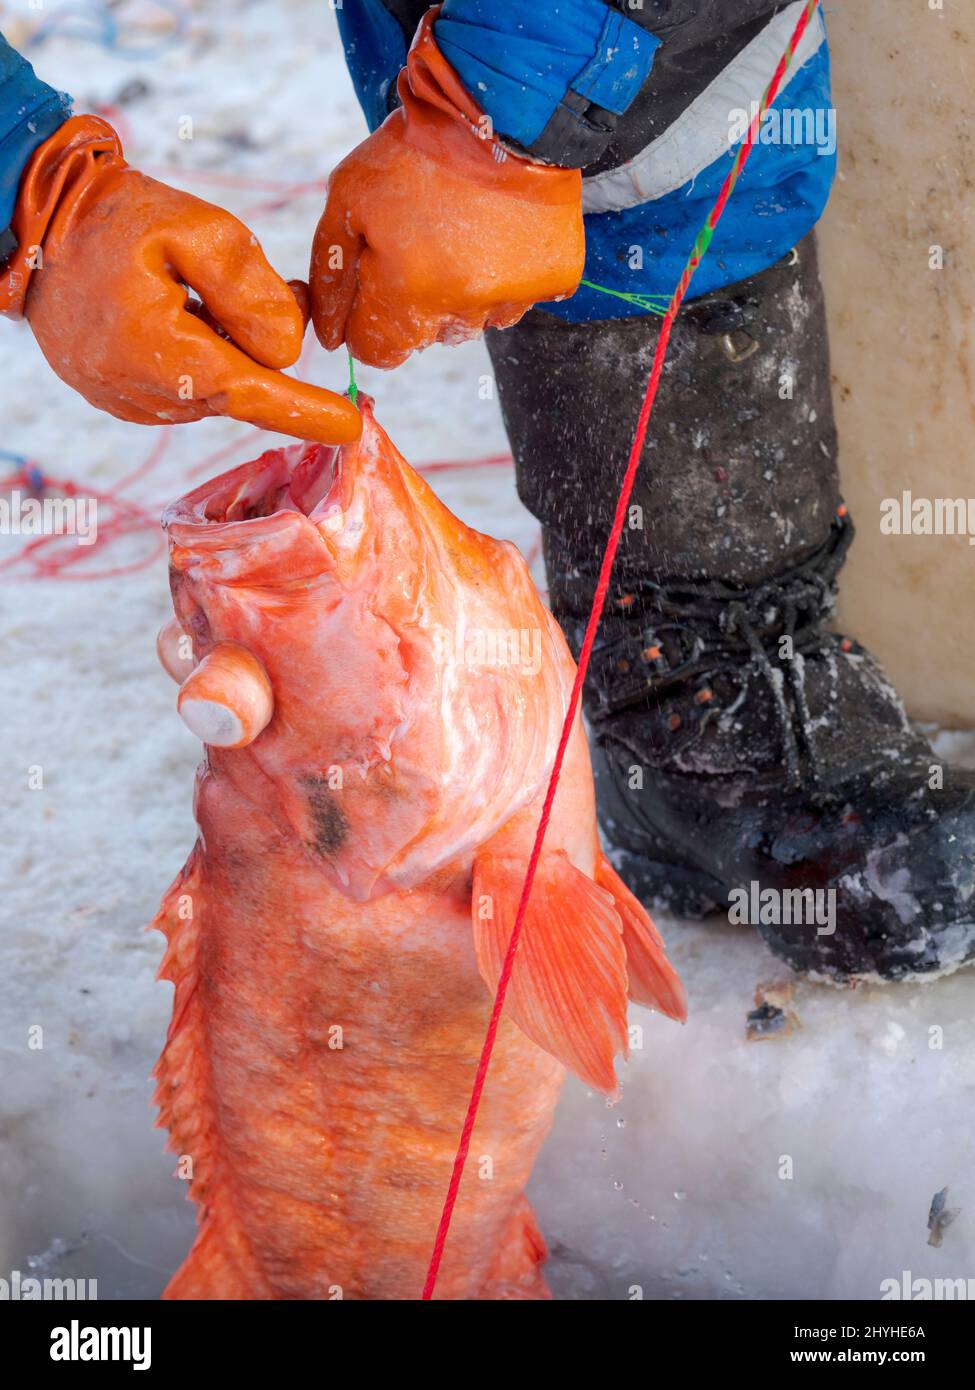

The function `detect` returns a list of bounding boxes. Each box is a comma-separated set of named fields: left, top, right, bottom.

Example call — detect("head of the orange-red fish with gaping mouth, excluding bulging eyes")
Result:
left=164, top=395, right=573, bottom=899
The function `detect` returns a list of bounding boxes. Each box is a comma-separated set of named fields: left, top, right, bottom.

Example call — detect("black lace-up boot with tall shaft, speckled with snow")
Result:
left=490, top=238, right=975, bottom=979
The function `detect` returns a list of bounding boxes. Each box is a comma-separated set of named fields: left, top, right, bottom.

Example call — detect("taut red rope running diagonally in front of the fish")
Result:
left=423, top=0, right=819, bottom=1300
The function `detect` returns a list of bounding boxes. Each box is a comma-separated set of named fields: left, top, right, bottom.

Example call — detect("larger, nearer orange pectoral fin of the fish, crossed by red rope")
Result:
left=472, top=851, right=627, bottom=1095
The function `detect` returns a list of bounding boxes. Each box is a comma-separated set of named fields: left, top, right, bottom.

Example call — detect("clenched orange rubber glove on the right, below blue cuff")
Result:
left=309, top=8, right=584, bottom=367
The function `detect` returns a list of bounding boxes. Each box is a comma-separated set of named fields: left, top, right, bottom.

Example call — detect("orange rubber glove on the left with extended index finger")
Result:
left=0, top=115, right=362, bottom=443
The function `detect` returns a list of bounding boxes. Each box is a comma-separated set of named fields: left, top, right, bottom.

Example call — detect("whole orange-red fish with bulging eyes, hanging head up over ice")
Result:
left=156, top=398, right=684, bottom=1298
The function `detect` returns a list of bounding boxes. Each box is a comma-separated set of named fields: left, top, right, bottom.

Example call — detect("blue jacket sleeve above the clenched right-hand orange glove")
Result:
left=434, top=0, right=661, bottom=167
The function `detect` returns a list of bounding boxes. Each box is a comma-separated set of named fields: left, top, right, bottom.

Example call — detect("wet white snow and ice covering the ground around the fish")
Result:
left=0, top=0, right=975, bottom=1298
